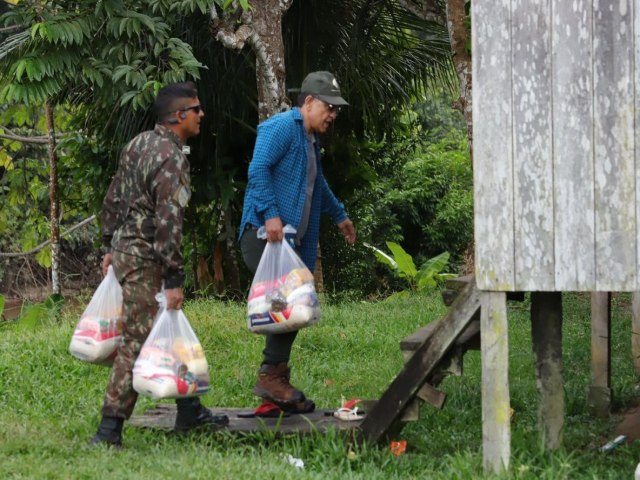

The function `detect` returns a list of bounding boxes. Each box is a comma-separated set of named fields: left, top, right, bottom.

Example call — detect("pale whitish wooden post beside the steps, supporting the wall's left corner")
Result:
left=480, top=292, right=511, bottom=473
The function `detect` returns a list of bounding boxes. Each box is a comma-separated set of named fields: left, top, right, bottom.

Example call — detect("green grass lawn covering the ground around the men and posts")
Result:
left=0, top=293, right=640, bottom=479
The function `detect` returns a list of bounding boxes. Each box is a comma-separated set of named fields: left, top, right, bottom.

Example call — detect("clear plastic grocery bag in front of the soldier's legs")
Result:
left=133, top=309, right=209, bottom=400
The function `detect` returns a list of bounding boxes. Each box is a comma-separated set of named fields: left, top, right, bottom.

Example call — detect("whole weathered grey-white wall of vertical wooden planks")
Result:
left=472, top=0, right=640, bottom=291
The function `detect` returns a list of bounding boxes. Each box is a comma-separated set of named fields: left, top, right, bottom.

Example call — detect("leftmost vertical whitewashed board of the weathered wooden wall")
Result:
left=471, top=0, right=515, bottom=290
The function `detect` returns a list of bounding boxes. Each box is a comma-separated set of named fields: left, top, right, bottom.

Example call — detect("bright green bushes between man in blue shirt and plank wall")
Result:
left=320, top=94, right=473, bottom=297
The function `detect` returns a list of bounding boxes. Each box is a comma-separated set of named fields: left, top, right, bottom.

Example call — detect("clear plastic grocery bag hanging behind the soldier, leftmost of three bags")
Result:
left=69, top=265, right=122, bottom=365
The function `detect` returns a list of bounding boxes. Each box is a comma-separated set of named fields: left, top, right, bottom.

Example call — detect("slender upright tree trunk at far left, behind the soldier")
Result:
left=44, top=101, right=61, bottom=295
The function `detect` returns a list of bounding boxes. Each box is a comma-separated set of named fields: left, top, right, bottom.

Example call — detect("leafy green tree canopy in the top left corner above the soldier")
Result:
left=0, top=0, right=206, bottom=109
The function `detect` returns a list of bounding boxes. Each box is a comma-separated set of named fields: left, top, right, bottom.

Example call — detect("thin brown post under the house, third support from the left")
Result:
left=587, top=292, right=612, bottom=417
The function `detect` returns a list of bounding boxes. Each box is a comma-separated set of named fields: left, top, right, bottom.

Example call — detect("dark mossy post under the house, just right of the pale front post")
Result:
left=531, top=292, right=564, bottom=450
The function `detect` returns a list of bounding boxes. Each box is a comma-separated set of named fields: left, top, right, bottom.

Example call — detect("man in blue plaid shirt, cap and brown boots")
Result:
left=240, top=71, right=356, bottom=412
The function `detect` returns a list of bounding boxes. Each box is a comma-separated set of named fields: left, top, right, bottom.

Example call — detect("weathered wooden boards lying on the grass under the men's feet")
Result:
left=128, top=403, right=364, bottom=434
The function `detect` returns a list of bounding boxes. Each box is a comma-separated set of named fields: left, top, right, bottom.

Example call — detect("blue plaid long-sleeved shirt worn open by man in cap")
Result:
left=240, top=107, right=347, bottom=272
